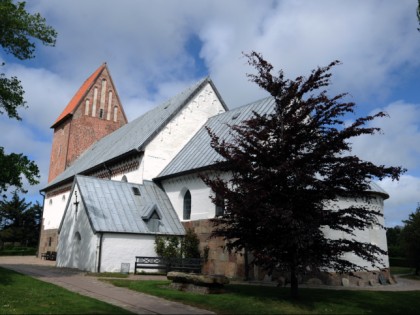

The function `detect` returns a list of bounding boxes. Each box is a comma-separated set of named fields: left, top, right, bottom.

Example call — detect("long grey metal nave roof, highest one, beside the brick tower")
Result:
left=43, top=78, right=226, bottom=190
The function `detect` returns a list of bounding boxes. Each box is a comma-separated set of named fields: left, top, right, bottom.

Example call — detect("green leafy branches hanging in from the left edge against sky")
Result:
left=0, top=0, right=57, bottom=198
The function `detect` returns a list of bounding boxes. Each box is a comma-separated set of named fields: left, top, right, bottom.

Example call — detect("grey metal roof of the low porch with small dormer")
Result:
left=60, top=175, right=185, bottom=235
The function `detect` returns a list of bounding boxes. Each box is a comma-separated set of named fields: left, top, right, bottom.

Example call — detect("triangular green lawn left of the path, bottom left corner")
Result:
left=0, top=268, right=130, bottom=314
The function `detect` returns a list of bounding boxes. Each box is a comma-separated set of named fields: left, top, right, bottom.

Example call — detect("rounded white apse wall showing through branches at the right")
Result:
left=324, top=194, right=389, bottom=270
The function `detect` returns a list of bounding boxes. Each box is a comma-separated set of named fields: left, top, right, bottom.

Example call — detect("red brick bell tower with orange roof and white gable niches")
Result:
left=48, top=63, right=127, bottom=182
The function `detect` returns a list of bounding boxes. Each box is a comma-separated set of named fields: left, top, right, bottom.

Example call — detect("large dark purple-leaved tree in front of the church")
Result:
left=203, top=52, right=404, bottom=297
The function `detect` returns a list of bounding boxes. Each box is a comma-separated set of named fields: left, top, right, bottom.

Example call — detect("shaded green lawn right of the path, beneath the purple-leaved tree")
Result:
left=103, top=280, right=420, bottom=314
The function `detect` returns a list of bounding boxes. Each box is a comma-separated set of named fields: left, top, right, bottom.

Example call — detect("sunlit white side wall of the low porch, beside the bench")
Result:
left=101, top=233, right=157, bottom=272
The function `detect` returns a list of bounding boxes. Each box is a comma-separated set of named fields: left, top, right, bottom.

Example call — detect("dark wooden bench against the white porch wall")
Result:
left=134, top=256, right=201, bottom=274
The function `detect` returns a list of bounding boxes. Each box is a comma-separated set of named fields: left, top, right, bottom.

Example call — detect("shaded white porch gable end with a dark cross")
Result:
left=56, top=189, right=98, bottom=272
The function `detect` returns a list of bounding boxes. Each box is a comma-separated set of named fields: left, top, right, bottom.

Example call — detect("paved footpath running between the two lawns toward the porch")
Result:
left=0, top=256, right=214, bottom=314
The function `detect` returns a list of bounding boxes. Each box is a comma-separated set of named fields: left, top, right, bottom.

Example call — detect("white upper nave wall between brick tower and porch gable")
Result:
left=42, top=191, right=70, bottom=230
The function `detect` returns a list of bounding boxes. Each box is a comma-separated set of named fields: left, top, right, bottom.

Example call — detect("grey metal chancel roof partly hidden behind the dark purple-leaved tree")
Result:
left=157, top=97, right=275, bottom=179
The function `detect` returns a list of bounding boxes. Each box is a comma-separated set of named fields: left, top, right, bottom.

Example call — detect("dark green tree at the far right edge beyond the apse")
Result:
left=401, top=205, right=420, bottom=275
